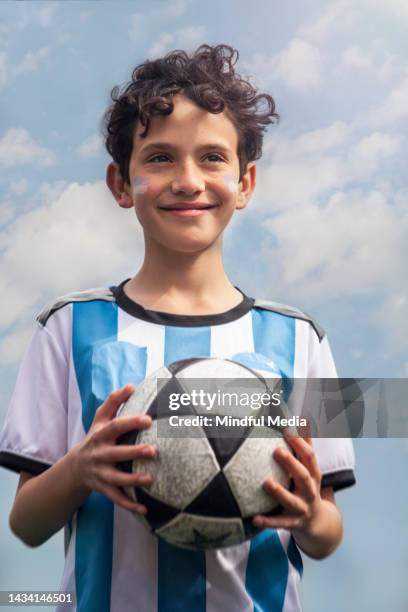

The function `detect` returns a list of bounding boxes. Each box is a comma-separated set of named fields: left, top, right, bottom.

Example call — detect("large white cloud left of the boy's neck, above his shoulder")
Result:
left=0, top=181, right=143, bottom=346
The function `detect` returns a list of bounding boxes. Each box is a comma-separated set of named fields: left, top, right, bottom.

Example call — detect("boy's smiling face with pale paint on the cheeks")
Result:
left=107, top=95, right=255, bottom=253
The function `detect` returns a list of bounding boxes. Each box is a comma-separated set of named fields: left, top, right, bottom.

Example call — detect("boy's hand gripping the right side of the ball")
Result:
left=253, top=434, right=322, bottom=533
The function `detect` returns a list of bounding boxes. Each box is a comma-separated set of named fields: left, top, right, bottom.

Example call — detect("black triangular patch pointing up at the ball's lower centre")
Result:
left=184, top=472, right=241, bottom=518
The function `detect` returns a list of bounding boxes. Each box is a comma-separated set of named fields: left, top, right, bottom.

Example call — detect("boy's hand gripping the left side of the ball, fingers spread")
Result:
left=71, top=385, right=156, bottom=514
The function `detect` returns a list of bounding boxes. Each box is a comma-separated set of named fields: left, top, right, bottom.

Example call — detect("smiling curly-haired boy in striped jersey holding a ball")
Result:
left=0, top=45, right=355, bottom=612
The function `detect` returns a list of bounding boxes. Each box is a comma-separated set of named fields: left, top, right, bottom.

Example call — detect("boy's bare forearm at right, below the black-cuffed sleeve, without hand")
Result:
left=292, top=499, right=343, bottom=559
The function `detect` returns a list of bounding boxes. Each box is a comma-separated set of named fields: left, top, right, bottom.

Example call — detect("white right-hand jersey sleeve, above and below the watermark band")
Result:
left=308, top=331, right=356, bottom=491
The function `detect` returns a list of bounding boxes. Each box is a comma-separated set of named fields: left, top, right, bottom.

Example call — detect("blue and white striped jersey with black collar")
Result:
left=0, top=279, right=355, bottom=612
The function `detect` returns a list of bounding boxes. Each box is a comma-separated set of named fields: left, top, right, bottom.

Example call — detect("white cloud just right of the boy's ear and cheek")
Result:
left=257, top=122, right=400, bottom=211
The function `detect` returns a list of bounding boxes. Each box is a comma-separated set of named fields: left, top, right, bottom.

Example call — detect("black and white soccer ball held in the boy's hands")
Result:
left=117, top=358, right=292, bottom=550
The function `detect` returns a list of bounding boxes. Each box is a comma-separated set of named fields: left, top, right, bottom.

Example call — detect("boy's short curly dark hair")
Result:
left=102, top=45, right=279, bottom=184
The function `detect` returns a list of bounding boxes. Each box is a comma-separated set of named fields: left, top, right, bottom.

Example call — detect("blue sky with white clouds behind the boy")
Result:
left=0, top=0, right=408, bottom=612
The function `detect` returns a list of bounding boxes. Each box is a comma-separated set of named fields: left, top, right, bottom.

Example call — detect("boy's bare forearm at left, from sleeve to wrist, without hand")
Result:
left=9, top=444, right=90, bottom=547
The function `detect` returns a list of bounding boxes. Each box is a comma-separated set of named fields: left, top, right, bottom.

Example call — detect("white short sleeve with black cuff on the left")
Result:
left=0, top=315, right=68, bottom=475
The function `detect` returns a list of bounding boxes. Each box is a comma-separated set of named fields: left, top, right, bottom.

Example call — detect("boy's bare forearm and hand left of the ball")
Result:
left=9, top=385, right=155, bottom=547
